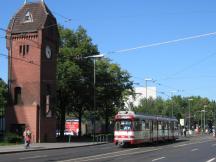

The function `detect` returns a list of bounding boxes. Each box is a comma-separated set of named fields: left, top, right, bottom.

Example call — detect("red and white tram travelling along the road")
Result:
left=114, top=111, right=179, bottom=147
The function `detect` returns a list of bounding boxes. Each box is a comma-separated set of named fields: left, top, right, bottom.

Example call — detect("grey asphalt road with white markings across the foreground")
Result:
left=0, top=136, right=216, bottom=162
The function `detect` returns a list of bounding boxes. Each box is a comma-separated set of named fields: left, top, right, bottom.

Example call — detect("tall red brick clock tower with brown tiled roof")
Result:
left=6, top=0, right=59, bottom=142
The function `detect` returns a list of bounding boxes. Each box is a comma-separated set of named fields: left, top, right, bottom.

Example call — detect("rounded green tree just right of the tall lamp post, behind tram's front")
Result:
left=96, top=59, right=133, bottom=132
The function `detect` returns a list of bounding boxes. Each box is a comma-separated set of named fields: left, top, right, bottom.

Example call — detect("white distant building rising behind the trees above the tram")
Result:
left=125, top=87, right=157, bottom=110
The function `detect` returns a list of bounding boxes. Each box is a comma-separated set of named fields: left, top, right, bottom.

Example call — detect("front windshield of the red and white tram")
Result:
left=115, top=120, right=132, bottom=131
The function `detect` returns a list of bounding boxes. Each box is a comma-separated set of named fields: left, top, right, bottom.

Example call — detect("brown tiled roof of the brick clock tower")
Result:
left=8, top=1, right=56, bottom=34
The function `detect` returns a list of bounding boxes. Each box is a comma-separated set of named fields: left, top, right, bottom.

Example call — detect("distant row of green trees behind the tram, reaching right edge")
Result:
left=133, top=96, right=216, bottom=126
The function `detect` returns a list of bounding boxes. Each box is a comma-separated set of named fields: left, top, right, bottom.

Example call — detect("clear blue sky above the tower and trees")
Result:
left=0, top=0, right=216, bottom=100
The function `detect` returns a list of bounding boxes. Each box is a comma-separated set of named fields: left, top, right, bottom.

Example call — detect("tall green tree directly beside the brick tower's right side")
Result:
left=57, top=27, right=98, bottom=136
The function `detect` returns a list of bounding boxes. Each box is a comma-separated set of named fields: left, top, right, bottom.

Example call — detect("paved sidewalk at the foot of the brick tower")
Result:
left=0, top=142, right=105, bottom=154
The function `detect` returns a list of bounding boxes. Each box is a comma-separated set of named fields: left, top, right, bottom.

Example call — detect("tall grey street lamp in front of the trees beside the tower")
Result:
left=85, top=54, right=104, bottom=135
